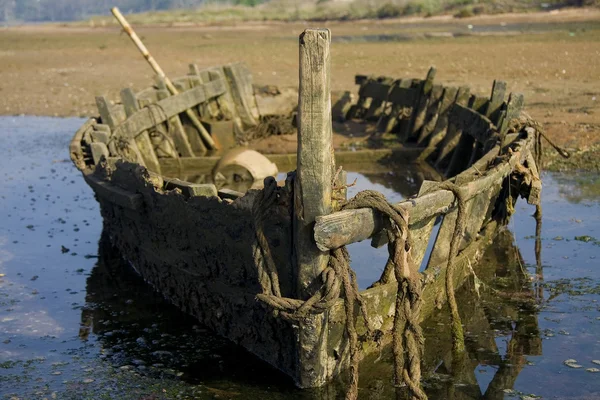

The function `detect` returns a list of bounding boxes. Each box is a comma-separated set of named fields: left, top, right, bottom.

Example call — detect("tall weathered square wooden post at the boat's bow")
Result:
left=294, top=29, right=335, bottom=387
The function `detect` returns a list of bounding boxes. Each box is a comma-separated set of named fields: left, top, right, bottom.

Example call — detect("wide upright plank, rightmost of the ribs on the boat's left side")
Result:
left=223, top=63, right=260, bottom=127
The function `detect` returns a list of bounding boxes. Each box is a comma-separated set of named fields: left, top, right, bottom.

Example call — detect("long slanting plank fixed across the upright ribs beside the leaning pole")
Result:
left=113, top=80, right=226, bottom=137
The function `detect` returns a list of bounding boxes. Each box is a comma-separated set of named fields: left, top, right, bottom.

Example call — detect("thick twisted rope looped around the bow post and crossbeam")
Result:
left=253, top=178, right=427, bottom=399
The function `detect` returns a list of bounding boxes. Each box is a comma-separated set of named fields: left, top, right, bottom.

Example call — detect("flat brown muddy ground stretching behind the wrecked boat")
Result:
left=0, top=10, right=600, bottom=170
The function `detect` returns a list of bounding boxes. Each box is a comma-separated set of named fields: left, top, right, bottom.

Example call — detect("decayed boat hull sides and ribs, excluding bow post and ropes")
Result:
left=70, top=44, right=539, bottom=387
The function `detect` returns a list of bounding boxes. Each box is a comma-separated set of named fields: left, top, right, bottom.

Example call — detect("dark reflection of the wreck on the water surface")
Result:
left=80, top=206, right=542, bottom=399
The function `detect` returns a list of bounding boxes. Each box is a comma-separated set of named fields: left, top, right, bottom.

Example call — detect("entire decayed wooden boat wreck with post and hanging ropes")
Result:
left=70, top=16, right=541, bottom=396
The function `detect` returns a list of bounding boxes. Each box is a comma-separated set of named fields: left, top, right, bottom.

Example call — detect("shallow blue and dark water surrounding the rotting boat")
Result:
left=0, top=117, right=600, bottom=399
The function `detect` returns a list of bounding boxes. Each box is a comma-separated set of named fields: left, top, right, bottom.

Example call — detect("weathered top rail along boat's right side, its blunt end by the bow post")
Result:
left=315, top=132, right=533, bottom=249
